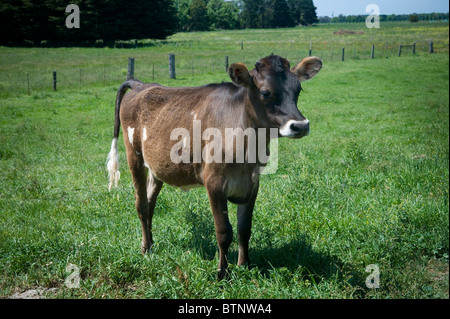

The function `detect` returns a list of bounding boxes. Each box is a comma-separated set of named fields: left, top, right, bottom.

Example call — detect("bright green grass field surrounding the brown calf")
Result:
left=0, top=23, right=449, bottom=298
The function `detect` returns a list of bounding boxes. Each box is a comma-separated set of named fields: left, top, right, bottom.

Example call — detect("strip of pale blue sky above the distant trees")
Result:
left=313, top=0, right=449, bottom=17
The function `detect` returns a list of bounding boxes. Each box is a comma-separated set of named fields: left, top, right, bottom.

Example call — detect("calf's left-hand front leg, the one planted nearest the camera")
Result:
left=206, top=181, right=233, bottom=280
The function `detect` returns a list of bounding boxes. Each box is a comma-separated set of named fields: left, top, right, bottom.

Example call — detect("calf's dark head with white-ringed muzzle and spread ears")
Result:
left=228, top=55, right=322, bottom=138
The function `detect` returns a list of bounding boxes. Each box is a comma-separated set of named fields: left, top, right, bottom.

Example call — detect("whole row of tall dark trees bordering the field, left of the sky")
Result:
left=0, top=0, right=318, bottom=46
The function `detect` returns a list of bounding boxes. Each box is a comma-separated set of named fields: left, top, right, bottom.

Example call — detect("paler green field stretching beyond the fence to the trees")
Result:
left=0, top=22, right=449, bottom=97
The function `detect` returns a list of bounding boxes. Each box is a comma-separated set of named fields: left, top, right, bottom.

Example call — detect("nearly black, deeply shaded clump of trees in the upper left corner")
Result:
left=0, top=0, right=177, bottom=45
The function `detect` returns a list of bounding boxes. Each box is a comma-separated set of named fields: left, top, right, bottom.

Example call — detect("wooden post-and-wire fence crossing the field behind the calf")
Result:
left=0, top=41, right=448, bottom=96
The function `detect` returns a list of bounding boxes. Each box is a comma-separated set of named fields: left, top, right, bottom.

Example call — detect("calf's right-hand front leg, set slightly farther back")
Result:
left=237, top=182, right=259, bottom=266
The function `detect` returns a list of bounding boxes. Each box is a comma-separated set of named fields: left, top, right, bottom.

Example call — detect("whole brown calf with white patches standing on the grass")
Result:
left=107, top=55, right=322, bottom=280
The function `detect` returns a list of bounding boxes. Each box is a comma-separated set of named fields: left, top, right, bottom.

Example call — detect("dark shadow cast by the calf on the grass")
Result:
left=186, top=210, right=365, bottom=294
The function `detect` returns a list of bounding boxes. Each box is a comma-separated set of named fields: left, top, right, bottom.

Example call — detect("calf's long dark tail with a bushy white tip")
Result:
left=106, top=79, right=142, bottom=191
